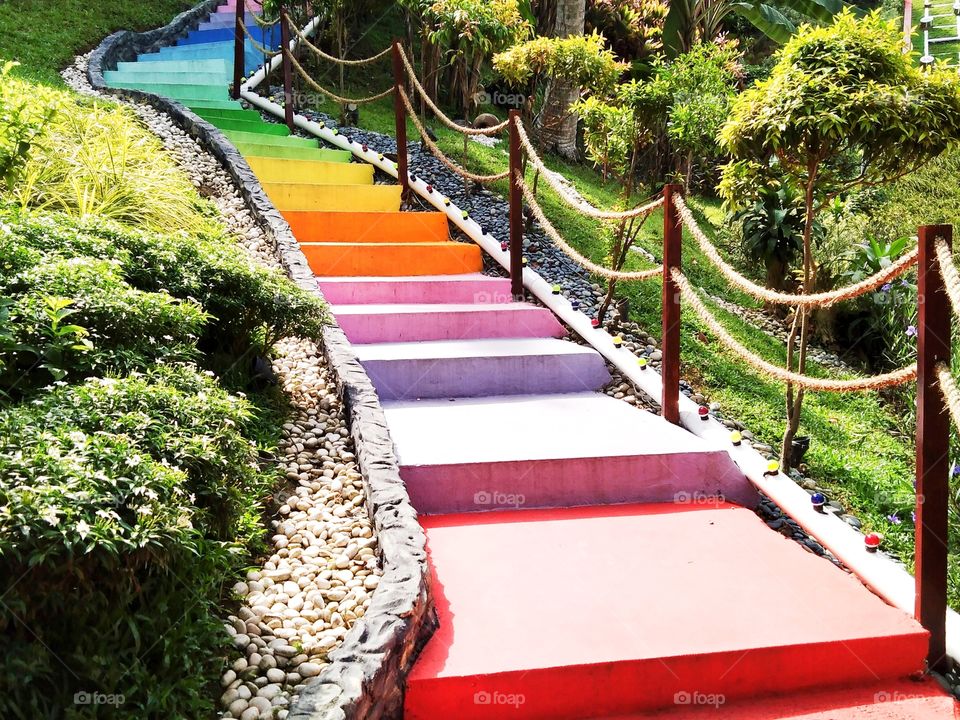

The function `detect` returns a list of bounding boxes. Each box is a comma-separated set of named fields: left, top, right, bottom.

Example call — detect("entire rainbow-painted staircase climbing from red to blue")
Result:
left=107, top=0, right=957, bottom=720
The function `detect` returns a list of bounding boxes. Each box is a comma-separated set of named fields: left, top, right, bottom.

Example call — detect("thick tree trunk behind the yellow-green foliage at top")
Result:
left=534, top=0, right=586, bottom=160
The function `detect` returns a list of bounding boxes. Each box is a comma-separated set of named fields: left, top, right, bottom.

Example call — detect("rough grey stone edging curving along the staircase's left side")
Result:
left=87, top=7, right=438, bottom=720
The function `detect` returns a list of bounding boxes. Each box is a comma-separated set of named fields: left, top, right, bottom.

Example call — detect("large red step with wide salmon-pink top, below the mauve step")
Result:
left=404, top=504, right=928, bottom=720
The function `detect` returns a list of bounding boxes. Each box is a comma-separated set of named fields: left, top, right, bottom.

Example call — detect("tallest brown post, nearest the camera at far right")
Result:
left=914, top=225, right=953, bottom=672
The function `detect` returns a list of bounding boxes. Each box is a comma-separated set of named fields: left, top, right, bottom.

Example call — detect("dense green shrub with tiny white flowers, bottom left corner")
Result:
left=0, top=366, right=272, bottom=718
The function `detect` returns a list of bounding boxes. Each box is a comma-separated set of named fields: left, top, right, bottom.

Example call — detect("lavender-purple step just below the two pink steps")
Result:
left=354, top=338, right=610, bottom=400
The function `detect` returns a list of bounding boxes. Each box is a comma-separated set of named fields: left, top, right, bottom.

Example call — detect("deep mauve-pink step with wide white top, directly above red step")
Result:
left=382, top=390, right=757, bottom=515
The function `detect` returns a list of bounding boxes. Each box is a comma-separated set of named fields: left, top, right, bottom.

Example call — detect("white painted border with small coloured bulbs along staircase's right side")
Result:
left=241, top=53, right=960, bottom=659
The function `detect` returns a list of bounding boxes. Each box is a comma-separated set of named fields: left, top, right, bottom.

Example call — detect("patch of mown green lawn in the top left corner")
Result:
left=0, top=0, right=195, bottom=85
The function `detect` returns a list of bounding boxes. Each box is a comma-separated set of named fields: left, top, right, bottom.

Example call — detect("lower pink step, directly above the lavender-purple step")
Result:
left=331, top=303, right=566, bottom=343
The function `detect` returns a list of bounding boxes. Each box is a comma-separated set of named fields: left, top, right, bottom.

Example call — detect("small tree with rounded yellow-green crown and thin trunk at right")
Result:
left=720, top=10, right=960, bottom=468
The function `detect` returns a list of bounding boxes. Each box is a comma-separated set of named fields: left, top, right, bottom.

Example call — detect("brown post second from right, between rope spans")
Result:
left=660, top=185, right=683, bottom=425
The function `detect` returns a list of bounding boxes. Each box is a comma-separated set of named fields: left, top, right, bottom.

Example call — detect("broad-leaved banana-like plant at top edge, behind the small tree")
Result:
left=663, top=0, right=844, bottom=57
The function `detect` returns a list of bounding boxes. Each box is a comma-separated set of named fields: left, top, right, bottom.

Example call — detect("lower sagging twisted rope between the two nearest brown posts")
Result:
left=671, top=268, right=917, bottom=392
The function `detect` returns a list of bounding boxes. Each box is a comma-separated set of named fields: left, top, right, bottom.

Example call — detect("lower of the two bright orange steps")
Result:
left=300, top=242, right=483, bottom=277
